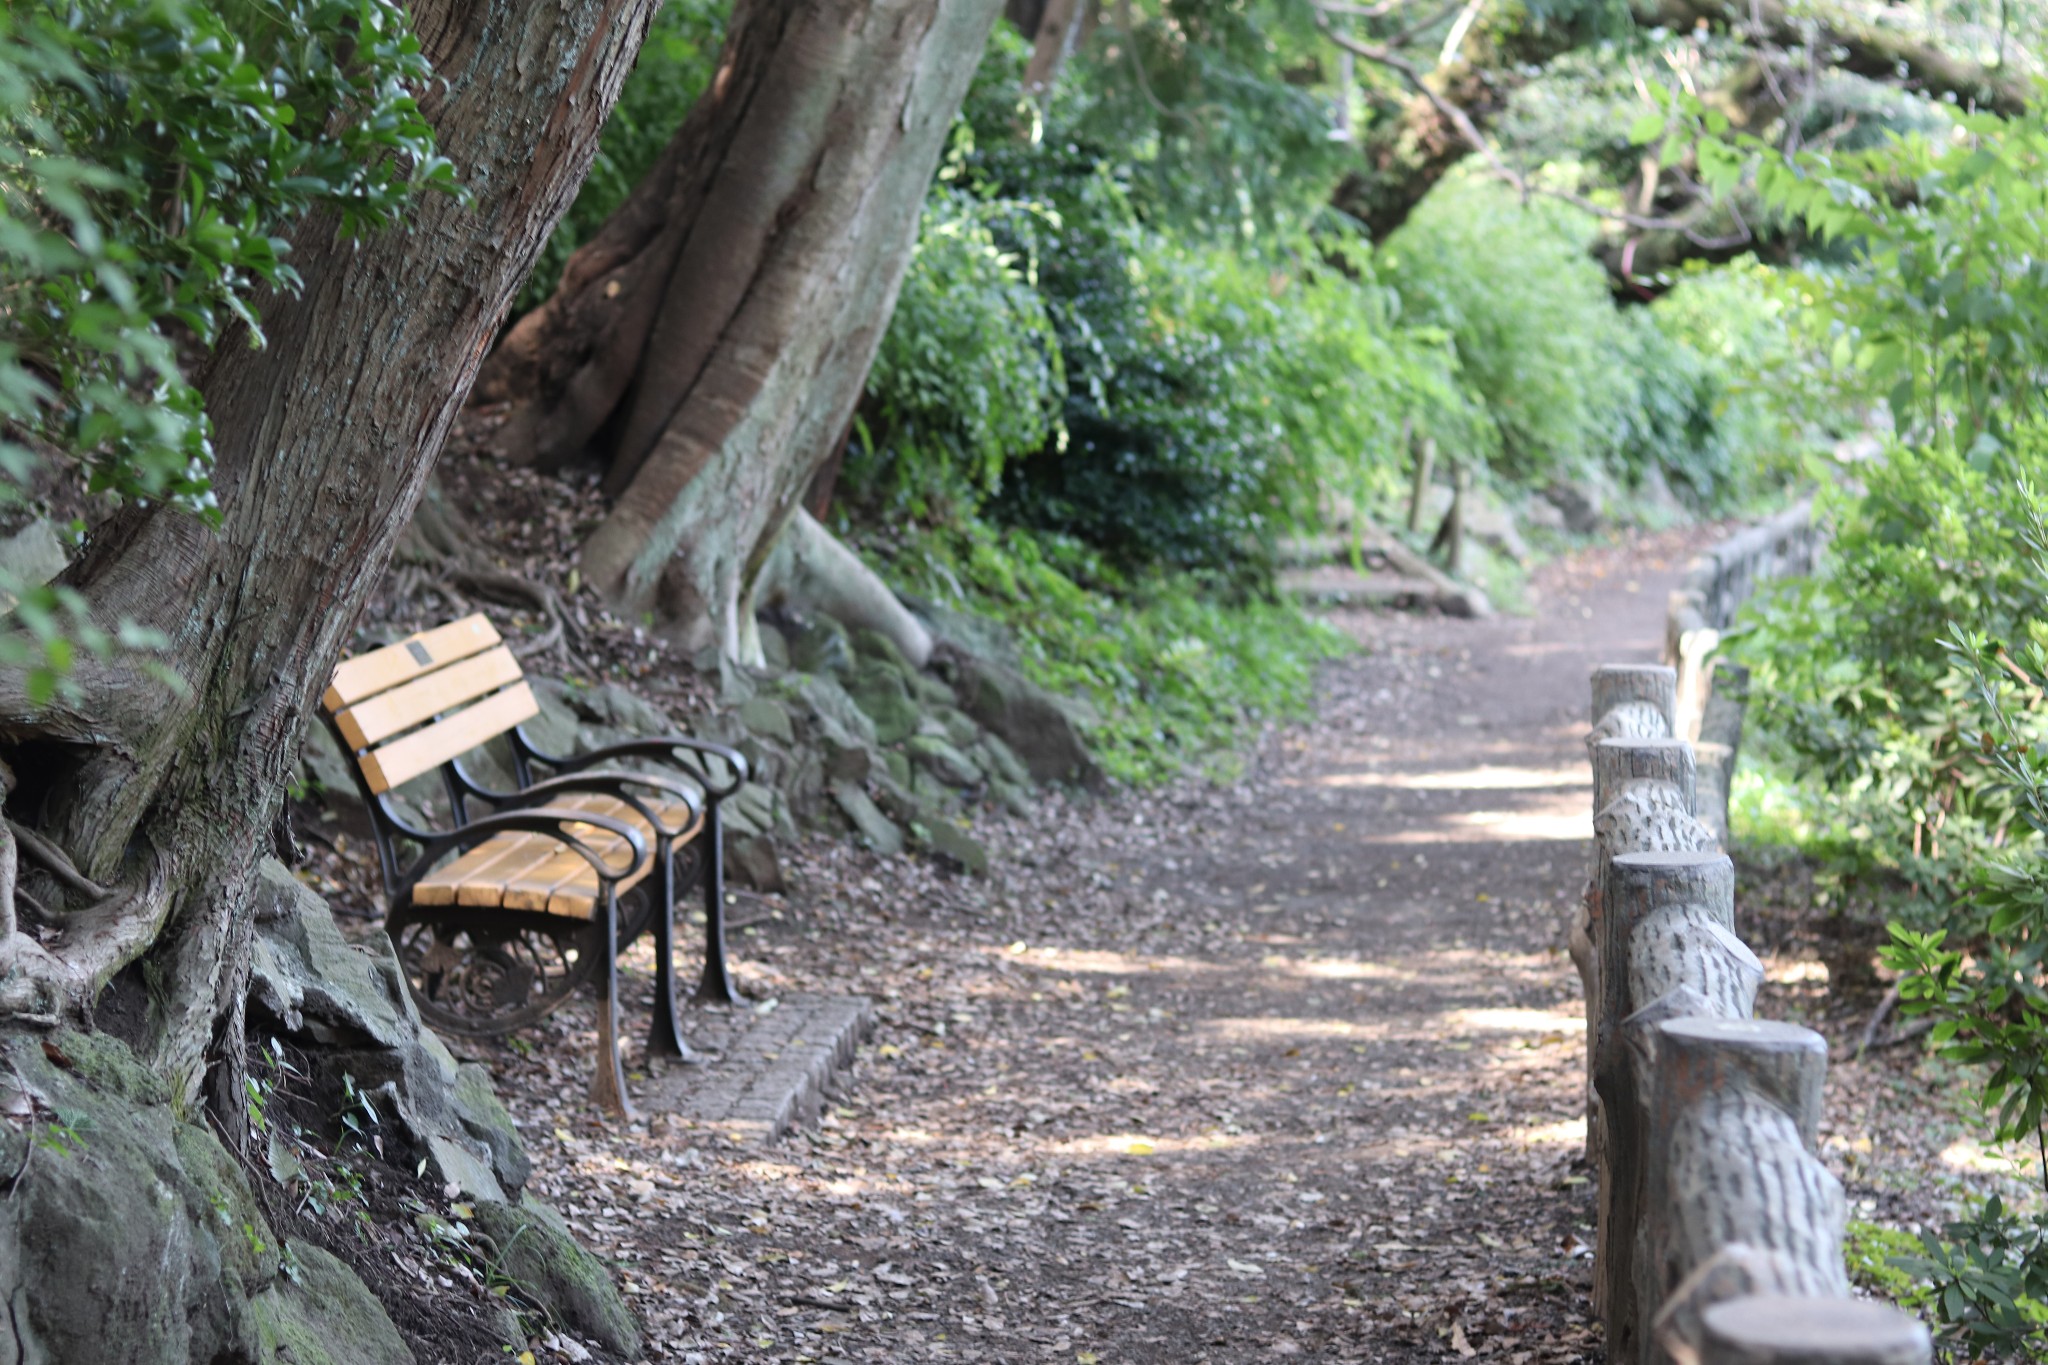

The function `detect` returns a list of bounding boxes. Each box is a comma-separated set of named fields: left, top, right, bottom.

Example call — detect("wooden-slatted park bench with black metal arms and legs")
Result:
left=322, top=616, right=748, bottom=1113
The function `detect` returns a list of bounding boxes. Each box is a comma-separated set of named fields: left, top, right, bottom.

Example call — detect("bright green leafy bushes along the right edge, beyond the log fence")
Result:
left=1728, top=113, right=2048, bottom=1359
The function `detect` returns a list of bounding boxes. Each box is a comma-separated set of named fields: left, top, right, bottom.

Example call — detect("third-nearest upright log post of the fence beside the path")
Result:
left=1591, top=849, right=1763, bottom=1361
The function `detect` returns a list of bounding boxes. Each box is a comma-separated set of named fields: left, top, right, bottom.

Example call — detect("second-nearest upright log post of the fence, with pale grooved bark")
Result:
left=1608, top=1011, right=1849, bottom=1365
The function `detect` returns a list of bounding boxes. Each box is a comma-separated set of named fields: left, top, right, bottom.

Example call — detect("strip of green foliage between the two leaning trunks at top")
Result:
left=512, top=0, right=733, bottom=313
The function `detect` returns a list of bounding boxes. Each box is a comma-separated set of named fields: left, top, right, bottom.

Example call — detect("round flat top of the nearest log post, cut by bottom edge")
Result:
left=1698, top=1293, right=1933, bottom=1365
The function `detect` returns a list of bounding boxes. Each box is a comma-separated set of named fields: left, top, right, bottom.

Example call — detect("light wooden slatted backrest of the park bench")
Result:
left=322, top=614, right=541, bottom=796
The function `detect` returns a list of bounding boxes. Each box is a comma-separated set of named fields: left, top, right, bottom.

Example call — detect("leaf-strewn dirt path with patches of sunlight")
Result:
left=494, top=532, right=1710, bottom=1365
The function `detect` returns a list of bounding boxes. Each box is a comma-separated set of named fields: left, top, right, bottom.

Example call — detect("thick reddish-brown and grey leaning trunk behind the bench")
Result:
left=477, top=0, right=1001, bottom=655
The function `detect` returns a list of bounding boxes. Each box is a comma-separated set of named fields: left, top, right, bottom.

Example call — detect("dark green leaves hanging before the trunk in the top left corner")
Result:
left=0, top=0, right=455, bottom=700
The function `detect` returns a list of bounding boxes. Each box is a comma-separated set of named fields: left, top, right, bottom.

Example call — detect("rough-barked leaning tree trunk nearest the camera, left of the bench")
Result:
left=0, top=0, right=657, bottom=1097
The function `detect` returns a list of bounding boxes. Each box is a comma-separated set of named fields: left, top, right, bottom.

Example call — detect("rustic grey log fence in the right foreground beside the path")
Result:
left=1571, top=665, right=1931, bottom=1365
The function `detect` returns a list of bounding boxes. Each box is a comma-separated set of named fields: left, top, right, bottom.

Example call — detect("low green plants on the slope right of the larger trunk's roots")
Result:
left=868, top=522, right=1343, bottom=782
